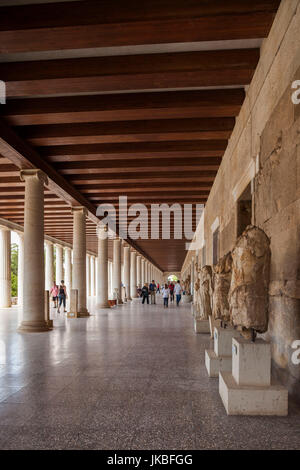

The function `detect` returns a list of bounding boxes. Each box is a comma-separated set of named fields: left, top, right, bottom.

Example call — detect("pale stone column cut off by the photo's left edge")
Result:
left=0, top=227, right=11, bottom=308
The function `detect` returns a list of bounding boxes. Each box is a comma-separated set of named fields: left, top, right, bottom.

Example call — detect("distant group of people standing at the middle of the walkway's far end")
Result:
left=138, top=280, right=182, bottom=308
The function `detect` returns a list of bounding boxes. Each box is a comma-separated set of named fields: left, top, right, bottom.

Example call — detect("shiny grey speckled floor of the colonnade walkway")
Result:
left=0, top=296, right=300, bottom=449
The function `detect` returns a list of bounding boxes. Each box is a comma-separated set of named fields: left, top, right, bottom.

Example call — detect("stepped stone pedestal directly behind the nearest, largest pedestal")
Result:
left=205, top=327, right=240, bottom=377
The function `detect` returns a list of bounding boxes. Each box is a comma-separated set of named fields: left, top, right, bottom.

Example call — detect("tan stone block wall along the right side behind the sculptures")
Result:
left=180, top=0, right=300, bottom=398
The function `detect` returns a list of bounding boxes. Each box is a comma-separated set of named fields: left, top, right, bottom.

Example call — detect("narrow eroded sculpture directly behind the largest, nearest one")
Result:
left=212, top=252, right=232, bottom=323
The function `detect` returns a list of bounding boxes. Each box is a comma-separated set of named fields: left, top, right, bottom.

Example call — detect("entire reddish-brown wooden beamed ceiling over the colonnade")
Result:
left=0, top=0, right=280, bottom=271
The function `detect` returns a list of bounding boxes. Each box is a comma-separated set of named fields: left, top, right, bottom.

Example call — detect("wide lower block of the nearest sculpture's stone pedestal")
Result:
left=219, top=372, right=288, bottom=416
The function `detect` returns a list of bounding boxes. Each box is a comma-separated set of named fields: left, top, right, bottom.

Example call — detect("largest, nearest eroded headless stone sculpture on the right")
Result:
left=229, top=225, right=271, bottom=338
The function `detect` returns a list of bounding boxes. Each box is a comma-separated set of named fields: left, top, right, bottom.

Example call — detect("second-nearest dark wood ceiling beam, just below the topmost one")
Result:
left=0, top=49, right=259, bottom=97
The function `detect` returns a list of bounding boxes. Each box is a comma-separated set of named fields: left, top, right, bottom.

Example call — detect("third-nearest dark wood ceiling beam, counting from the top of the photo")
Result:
left=0, top=88, right=245, bottom=126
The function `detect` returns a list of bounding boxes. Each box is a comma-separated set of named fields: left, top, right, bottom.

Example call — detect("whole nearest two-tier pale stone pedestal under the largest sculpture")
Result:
left=219, top=337, right=288, bottom=416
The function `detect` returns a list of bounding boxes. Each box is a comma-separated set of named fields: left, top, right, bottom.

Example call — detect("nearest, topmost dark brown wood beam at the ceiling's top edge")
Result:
left=0, top=0, right=279, bottom=53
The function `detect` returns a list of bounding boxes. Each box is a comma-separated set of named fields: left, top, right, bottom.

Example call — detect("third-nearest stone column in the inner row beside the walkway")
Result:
left=96, top=226, right=109, bottom=308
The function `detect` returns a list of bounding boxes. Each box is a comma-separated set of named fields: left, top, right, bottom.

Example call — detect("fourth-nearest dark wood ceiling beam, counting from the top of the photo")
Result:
left=15, top=117, right=235, bottom=146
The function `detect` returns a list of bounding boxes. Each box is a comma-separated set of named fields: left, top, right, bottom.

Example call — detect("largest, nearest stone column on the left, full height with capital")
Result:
left=19, top=170, right=49, bottom=332
